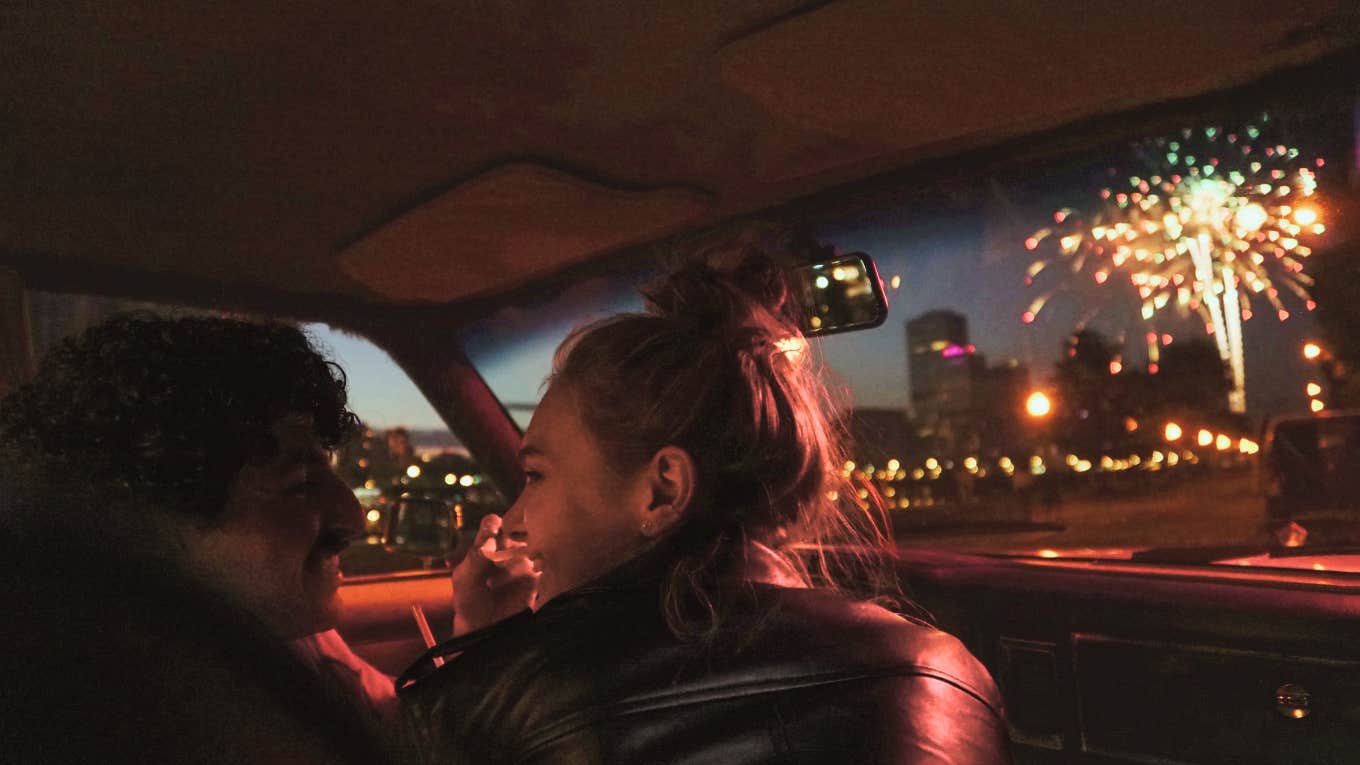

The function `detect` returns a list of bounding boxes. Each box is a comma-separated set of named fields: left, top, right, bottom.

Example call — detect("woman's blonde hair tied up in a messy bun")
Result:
left=552, top=242, right=898, bottom=637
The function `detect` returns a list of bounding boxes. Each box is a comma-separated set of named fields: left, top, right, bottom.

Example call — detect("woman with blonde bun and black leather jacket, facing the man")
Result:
left=398, top=255, right=1009, bottom=764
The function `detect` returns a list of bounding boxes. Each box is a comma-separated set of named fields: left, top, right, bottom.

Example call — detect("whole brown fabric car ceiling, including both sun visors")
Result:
left=0, top=0, right=1360, bottom=312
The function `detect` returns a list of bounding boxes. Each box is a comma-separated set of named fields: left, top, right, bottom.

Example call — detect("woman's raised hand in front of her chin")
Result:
left=450, top=515, right=539, bottom=637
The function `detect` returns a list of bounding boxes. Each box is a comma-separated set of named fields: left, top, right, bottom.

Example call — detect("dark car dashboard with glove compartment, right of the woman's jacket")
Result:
left=900, top=551, right=1360, bottom=764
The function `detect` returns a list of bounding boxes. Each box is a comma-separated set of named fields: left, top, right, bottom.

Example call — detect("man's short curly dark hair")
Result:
left=0, top=312, right=358, bottom=521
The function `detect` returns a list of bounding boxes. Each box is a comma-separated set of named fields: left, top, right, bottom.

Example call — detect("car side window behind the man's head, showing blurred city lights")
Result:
left=9, top=290, right=506, bottom=577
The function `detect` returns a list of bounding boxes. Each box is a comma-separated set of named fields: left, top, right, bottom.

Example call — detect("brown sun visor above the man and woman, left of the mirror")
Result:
left=340, top=163, right=711, bottom=302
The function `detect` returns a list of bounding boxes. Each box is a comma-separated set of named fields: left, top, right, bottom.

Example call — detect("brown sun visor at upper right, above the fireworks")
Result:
left=718, top=0, right=1340, bottom=172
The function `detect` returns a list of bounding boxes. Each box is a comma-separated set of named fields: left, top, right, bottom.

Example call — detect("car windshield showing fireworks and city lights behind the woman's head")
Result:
left=462, top=83, right=1360, bottom=565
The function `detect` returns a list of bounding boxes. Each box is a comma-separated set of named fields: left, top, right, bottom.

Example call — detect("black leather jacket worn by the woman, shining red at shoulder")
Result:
left=397, top=547, right=1010, bottom=765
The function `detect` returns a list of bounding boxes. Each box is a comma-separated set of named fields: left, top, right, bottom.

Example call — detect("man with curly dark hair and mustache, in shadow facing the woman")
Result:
left=0, top=314, right=392, bottom=761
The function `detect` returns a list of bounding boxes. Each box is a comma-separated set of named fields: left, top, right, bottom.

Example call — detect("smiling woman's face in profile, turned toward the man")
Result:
left=506, top=384, right=650, bottom=607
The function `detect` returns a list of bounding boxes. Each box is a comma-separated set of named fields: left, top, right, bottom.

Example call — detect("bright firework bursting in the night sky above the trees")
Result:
left=1021, top=116, right=1326, bottom=412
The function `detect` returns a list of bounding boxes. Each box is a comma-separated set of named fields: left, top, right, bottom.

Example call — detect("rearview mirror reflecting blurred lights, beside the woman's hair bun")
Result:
left=789, top=252, right=888, bottom=338
